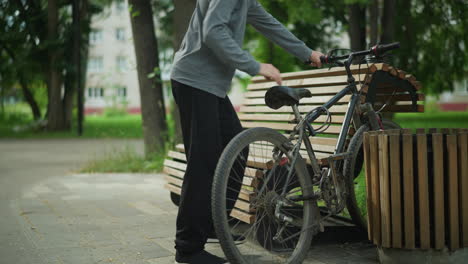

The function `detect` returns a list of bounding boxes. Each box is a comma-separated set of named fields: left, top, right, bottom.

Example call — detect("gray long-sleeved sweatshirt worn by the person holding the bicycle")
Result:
left=171, top=0, right=312, bottom=98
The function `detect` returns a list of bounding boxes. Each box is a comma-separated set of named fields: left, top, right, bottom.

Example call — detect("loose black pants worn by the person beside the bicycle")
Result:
left=172, top=80, right=242, bottom=254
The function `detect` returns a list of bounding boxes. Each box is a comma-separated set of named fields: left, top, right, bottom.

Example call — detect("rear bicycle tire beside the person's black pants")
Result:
left=211, top=127, right=318, bottom=264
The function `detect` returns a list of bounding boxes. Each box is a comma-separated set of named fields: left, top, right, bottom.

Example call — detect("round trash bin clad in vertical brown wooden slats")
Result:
left=364, top=129, right=468, bottom=263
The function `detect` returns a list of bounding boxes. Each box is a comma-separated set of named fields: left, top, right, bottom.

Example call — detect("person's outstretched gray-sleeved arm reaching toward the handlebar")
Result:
left=247, top=0, right=312, bottom=62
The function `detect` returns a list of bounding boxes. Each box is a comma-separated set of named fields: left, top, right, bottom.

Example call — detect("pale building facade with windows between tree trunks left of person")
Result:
left=85, top=1, right=141, bottom=114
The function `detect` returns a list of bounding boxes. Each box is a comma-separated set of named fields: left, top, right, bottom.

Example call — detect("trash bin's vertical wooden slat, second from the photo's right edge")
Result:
left=447, top=135, right=460, bottom=250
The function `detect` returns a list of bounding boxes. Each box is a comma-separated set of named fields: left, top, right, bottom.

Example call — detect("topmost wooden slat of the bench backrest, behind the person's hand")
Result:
left=252, top=63, right=383, bottom=83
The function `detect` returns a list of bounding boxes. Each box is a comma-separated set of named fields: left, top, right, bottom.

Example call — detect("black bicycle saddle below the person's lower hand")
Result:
left=265, top=86, right=312, bottom=109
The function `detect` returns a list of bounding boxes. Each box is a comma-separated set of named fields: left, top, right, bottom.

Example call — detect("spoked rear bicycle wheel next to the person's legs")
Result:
left=212, top=128, right=318, bottom=263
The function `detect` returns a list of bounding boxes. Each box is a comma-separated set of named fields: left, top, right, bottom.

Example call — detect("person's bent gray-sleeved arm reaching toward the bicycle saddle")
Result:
left=202, top=0, right=260, bottom=76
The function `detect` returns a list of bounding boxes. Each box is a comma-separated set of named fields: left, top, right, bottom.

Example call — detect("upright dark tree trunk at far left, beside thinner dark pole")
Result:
left=47, top=0, right=65, bottom=131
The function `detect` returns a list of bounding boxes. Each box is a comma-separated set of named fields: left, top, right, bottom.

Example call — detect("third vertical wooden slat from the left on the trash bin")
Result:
left=389, top=135, right=403, bottom=248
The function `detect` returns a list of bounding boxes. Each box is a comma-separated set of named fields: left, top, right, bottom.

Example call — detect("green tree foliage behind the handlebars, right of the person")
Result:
left=246, top=0, right=468, bottom=94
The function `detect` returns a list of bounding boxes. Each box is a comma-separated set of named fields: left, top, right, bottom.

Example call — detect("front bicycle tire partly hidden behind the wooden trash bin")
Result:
left=343, top=119, right=401, bottom=231
